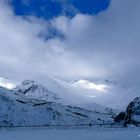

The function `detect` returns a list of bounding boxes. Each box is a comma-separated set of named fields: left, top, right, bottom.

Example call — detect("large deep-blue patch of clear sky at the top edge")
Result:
left=11, top=0, right=110, bottom=19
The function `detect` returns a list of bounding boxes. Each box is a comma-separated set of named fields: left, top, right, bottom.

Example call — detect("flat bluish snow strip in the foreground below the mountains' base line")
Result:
left=0, top=128, right=140, bottom=140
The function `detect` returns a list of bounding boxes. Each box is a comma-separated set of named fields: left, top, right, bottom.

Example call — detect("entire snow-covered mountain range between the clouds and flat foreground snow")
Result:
left=0, top=77, right=140, bottom=126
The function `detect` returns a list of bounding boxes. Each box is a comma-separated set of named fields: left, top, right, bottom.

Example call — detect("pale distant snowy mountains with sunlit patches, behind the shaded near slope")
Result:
left=0, top=77, right=131, bottom=110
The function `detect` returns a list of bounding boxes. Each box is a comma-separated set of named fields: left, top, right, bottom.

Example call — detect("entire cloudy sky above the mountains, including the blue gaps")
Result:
left=0, top=0, right=140, bottom=84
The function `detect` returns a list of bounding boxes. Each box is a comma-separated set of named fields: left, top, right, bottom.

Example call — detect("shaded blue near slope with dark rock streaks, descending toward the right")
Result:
left=0, top=86, right=113, bottom=126
